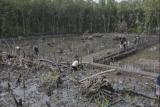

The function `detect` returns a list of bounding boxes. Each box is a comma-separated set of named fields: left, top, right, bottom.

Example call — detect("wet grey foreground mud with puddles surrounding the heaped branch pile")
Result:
left=0, top=59, right=158, bottom=107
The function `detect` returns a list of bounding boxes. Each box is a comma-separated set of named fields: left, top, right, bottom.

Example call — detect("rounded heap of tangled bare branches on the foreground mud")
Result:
left=81, top=76, right=114, bottom=102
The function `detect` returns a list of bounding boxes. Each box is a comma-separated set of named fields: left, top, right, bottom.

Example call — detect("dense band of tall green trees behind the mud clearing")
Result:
left=0, top=0, right=160, bottom=36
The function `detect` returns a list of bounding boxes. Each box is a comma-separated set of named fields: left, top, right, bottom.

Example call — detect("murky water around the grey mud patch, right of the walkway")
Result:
left=118, top=44, right=159, bottom=72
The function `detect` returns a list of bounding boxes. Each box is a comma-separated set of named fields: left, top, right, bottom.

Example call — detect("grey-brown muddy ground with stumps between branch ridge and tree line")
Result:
left=0, top=34, right=150, bottom=61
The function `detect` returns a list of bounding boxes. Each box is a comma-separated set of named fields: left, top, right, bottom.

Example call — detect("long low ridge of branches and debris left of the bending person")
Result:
left=0, top=51, right=70, bottom=71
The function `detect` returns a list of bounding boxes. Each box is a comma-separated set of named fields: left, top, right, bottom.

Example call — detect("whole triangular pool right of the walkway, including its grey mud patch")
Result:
left=118, top=44, right=159, bottom=72
